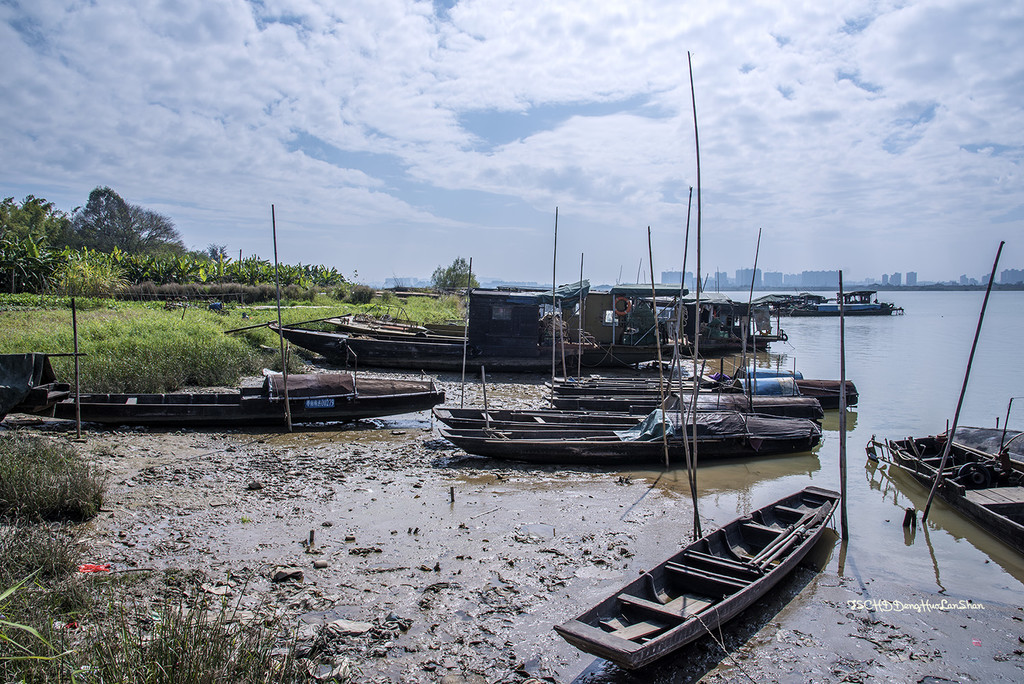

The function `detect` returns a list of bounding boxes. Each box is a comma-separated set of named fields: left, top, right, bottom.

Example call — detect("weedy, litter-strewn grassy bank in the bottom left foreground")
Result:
left=0, top=434, right=305, bottom=684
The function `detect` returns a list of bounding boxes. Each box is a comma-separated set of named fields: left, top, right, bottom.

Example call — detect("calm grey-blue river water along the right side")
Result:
left=635, top=292, right=1024, bottom=605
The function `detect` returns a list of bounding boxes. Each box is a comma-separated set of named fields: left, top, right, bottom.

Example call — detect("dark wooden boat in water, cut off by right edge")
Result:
left=867, top=434, right=1024, bottom=553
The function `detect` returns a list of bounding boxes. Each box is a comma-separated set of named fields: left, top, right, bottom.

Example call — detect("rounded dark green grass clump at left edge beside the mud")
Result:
left=0, top=434, right=103, bottom=521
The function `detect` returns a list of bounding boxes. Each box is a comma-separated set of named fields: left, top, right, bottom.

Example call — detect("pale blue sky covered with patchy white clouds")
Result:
left=0, top=0, right=1024, bottom=283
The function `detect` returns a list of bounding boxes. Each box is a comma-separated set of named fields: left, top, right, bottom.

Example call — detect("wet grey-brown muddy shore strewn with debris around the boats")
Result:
left=5, top=370, right=1024, bottom=683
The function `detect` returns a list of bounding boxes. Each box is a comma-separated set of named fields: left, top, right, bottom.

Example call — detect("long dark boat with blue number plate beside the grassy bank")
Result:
left=40, top=373, right=444, bottom=427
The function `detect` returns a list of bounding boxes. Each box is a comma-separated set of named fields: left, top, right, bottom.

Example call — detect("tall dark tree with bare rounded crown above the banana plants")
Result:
left=71, top=187, right=185, bottom=254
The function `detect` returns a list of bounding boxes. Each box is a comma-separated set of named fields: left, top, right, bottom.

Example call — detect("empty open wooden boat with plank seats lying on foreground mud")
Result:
left=554, top=486, right=840, bottom=670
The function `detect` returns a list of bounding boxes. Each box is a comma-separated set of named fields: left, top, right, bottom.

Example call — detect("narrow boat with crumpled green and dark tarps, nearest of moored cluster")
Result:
left=439, top=410, right=821, bottom=466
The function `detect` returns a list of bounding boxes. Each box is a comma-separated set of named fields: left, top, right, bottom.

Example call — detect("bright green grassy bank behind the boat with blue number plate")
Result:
left=0, top=296, right=461, bottom=392
